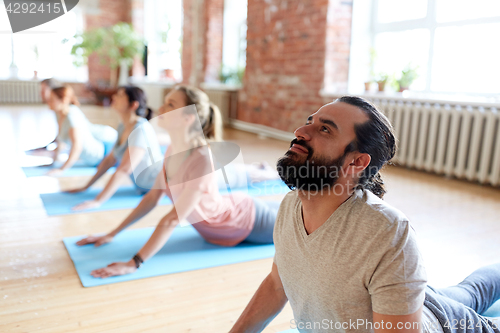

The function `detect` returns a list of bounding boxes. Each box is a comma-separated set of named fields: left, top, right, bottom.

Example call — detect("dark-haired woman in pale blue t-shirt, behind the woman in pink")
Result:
left=68, top=86, right=163, bottom=210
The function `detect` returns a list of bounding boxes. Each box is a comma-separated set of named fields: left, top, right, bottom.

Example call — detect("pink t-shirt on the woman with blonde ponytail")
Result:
left=163, top=146, right=255, bottom=246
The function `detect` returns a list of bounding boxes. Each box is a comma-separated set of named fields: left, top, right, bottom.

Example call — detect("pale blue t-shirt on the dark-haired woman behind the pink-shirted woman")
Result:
left=113, top=118, right=163, bottom=190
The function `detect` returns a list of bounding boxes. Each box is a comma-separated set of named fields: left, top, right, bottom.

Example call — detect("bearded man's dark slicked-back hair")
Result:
left=335, top=96, right=396, bottom=198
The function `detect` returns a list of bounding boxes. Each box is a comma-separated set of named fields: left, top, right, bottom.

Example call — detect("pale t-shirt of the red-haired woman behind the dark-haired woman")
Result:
left=57, top=105, right=117, bottom=166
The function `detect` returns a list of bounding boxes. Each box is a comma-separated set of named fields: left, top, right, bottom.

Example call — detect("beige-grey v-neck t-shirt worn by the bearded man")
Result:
left=274, top=190, right=427, bottom=332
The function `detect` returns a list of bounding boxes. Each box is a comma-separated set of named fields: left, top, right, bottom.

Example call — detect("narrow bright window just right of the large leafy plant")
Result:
left=144, top=0, right=183, bottom=81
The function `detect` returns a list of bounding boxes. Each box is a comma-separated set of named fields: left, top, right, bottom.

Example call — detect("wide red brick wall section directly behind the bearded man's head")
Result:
left=238, top=0, right=351, bottom=131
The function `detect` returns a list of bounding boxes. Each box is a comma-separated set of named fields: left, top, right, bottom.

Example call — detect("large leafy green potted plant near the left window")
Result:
left=63, top=22, right=144, bottom=89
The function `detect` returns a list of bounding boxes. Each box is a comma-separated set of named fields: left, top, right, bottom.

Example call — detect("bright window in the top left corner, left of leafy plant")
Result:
left=0, top=1, right=88, bottom=82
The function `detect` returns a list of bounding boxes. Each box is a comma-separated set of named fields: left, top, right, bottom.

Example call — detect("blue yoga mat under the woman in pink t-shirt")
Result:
left=63, top=226, right=274, bottom=287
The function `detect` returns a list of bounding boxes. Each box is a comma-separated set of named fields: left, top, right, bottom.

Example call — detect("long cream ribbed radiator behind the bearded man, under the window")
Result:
left=371, top=98, right=500, bottom=186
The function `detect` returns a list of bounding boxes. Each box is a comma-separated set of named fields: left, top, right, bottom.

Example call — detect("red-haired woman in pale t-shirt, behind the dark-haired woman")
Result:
left=47, top=86, right=116, bottom=174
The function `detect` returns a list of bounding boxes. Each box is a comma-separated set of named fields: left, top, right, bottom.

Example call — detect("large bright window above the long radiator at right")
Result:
left=349, top=0, right=500, bottom=96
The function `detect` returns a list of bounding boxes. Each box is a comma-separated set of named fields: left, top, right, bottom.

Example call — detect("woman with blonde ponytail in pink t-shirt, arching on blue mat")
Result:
left=77, top=86, right=279, bottom=278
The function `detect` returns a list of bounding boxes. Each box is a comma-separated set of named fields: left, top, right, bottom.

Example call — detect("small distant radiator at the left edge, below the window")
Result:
left=0, top=80, right=42, bottom=104
